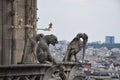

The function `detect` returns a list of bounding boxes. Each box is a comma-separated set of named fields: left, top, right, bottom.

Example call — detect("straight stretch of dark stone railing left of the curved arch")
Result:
left=0, top=64, right=51, bottom=80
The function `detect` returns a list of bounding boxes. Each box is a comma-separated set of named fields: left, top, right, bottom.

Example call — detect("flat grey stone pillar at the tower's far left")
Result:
left=1, top=0, right=12, bottom=65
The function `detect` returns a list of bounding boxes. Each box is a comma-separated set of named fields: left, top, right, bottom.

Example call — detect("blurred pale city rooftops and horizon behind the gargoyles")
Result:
left=50, top=36, right=120, bottom=80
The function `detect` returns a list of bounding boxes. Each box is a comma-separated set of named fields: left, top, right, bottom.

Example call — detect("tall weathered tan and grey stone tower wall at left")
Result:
left=0, top=0, right=37, bottom=65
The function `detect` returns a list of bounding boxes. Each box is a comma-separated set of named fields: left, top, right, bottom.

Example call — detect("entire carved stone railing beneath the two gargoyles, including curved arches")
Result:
left=0, top=62, right=85, bottom=80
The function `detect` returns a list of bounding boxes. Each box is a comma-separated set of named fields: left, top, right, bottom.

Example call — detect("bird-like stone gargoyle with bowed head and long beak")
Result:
left=63, top=33, right=88, bottom=62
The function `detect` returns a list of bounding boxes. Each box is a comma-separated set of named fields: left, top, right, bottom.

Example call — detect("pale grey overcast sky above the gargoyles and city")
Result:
left=37, top=0, right=120, bottom=43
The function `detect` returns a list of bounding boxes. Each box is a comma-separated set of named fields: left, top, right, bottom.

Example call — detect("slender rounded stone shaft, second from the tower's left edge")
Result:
left=10, top=0, right=18, bottom=64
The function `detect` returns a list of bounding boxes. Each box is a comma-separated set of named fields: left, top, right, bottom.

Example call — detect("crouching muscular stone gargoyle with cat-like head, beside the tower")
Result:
left=36, top=34, right=58, bottom=63
